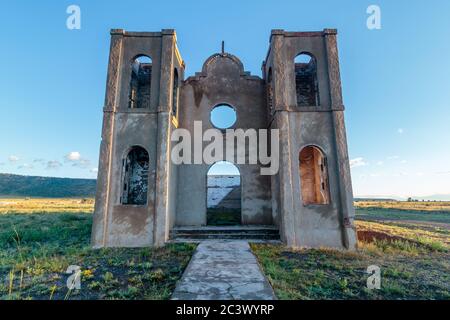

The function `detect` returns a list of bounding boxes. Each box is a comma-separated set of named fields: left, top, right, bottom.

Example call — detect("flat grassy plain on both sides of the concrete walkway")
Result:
left=0, top=198, right=450, bottom=300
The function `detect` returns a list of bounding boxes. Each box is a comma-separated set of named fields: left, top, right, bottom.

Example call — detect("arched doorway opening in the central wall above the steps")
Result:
left=206, top=161, right=241, bottom=226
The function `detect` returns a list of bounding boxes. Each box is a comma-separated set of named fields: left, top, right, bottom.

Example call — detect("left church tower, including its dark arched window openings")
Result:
left=92, top=30, right=184, bottom=247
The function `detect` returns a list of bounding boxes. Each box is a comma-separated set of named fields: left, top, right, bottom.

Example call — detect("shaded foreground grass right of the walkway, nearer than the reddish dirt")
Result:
left=251, top=243, right=450, bottom=300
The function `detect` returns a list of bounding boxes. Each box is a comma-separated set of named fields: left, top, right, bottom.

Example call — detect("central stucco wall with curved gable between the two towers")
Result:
left=176, top=54, right=272, bottom=225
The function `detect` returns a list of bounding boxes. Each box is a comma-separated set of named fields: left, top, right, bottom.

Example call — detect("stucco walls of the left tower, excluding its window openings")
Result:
left=92, top=29, right=179, bottom=247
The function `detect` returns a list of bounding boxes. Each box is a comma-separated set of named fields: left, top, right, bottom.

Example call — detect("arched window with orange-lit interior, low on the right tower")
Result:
left=299, top=146, right=329, bottom=205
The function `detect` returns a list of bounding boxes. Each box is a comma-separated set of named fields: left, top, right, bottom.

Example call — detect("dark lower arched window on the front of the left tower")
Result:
left=121, top=147, right=149, bottom=205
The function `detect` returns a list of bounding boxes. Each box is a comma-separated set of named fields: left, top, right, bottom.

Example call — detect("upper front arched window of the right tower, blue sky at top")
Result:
left=295, top=53, right=320, bottom=107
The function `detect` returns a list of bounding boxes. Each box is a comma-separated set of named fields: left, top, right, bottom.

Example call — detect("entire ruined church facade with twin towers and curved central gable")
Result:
left=91, top=29, right=356, bottom=250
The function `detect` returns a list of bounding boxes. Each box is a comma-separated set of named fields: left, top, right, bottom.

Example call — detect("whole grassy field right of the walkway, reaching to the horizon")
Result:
left=252, top=201, right=450, bottom=300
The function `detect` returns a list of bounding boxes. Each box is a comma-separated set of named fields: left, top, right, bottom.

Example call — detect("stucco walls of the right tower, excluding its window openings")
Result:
left=263, top=30, right=355, bottom=249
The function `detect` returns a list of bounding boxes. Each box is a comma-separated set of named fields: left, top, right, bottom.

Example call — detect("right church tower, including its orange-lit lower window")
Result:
left=263, top=29, right=356, bottom=249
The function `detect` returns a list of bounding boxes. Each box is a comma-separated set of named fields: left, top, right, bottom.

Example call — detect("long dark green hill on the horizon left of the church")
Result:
left=0, top=173, right=96, bottom=198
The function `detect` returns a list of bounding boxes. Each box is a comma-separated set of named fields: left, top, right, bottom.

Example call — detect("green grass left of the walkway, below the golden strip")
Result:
left=0, top=209, right=196, bottom=300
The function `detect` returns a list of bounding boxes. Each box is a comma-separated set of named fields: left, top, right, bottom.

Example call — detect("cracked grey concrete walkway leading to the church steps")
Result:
left=172, top=240, right=276, bottom=300
